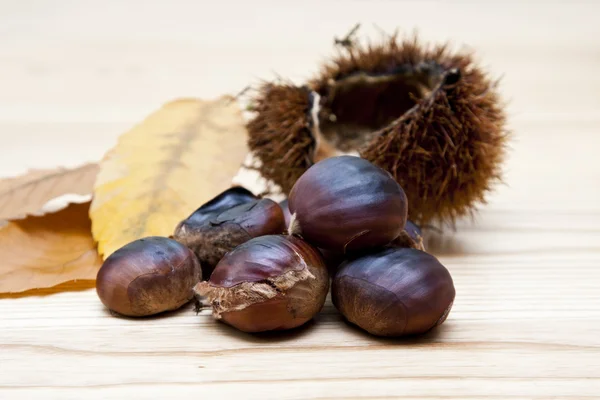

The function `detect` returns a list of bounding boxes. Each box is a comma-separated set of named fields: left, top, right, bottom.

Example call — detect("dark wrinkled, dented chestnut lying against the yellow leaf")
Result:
left=173, top=188, right=285, bottom=279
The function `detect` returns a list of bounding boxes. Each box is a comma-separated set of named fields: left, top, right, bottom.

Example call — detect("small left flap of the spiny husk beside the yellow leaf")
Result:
left=247, top=84, right=315, bottom=193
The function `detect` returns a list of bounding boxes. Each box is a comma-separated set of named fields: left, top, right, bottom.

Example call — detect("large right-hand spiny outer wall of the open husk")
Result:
left=361, top=51, right=507, bottom=224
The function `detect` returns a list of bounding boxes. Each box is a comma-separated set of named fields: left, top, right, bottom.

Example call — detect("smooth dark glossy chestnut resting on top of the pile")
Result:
left=289, top=156, right=408, bottom=254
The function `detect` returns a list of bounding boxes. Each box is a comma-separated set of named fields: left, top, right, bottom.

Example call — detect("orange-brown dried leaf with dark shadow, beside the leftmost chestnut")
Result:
left=0, top=202, right=102, bottom=293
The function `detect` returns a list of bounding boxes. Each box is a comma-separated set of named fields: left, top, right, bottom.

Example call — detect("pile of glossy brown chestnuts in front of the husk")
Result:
left=96, top=156, right=455, bottom=336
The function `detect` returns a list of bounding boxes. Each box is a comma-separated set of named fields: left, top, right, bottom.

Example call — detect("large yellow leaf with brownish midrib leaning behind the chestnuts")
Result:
left=90, top=97, right=247, bottom=257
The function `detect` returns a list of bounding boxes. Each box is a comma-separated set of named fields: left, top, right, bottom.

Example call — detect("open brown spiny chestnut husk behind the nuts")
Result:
left=247, top=36, right=508, bottom=224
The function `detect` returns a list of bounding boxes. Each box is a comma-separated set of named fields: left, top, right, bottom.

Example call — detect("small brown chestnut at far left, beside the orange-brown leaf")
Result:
left=96, top=236, right=202, bottom=317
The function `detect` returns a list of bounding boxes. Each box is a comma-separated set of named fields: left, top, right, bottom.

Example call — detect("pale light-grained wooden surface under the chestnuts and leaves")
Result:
left=0, top=0, right=600, bottom=399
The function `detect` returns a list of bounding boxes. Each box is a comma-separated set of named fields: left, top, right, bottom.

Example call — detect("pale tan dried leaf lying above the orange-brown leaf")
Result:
left=0, top=164, right=98, bottom=220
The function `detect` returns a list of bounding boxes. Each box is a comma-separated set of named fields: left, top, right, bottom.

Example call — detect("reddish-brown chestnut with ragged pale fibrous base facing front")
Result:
left=194, top=235, right=329, bottom=332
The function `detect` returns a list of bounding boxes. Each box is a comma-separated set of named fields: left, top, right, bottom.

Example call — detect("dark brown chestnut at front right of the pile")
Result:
left=331, top=248, right=455, bottom=336
